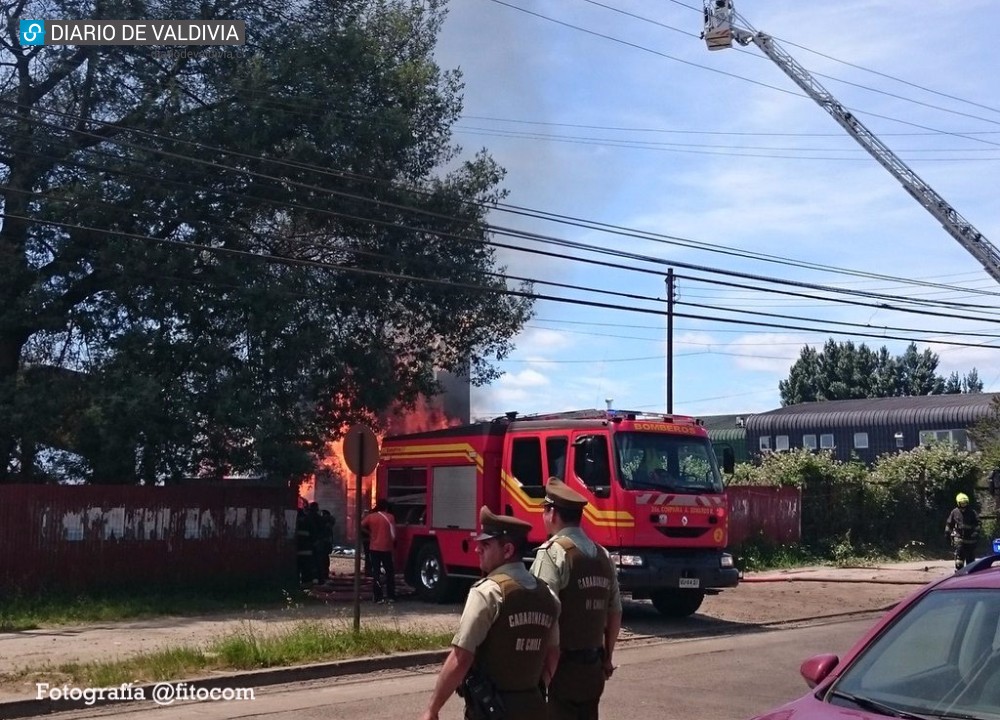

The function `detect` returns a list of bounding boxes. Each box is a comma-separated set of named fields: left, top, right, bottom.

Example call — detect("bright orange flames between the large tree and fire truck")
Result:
left=310, top=390, right=462, bottom=541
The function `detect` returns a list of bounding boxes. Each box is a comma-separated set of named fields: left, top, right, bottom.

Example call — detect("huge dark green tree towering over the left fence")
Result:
left=0, top=0, right=531, bottom=483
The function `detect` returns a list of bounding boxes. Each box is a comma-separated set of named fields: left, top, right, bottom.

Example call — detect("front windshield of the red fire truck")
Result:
left=615, top=432, right=723, bottom=493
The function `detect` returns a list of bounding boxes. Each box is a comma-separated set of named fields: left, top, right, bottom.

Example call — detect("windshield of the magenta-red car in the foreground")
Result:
left=824, top=589, right=1000, bottom=720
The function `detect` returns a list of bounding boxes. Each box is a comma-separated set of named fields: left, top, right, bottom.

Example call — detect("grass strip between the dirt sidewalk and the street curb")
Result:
left=15, top=621, right=452, bottom=687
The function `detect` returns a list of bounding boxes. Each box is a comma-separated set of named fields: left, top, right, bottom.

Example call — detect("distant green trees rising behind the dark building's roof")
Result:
left=778, top=339, right=983, bottom=405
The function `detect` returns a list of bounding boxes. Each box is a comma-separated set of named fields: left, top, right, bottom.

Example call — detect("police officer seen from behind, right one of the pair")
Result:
left=531, top=477, right=622, bottom=720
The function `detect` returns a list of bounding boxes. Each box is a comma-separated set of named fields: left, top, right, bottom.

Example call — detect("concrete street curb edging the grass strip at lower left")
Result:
left=0, top=650, right=449, bottom=720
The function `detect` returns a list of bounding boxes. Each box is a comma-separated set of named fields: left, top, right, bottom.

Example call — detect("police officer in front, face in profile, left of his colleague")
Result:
left=421, top=506, right=559, bottom=720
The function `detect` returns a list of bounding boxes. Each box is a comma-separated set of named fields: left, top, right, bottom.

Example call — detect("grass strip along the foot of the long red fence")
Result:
left=0, top=587, right=293, bottom=632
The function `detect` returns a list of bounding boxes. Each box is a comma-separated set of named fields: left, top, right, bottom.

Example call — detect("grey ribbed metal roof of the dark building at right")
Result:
left=747, top=393, right=1000, bottom=434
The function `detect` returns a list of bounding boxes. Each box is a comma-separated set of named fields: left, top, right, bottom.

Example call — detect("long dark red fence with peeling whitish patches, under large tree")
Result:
left=0, top=485, right=296, bottom=592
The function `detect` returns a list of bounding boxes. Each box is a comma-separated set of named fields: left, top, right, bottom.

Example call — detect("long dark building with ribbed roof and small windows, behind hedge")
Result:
left=746, top=393, right=1000, bottom=463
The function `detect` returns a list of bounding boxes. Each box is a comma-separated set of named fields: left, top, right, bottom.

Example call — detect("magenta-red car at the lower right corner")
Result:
left=756, top=555, right=1000, bottom=720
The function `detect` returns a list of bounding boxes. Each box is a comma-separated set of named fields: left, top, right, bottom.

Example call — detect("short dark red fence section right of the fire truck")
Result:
left=726, top=485, right=802, bottom=546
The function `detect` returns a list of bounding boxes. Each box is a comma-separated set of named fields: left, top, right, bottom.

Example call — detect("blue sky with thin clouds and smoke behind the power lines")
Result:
left=437, top=0, right=1000, bottom=416
